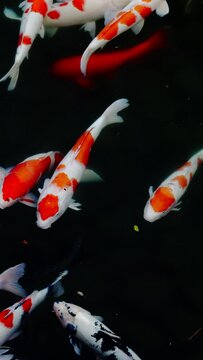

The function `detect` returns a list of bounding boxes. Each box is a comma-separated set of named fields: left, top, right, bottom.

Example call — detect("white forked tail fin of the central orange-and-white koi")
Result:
left=102, top=99, right=129, bottom=126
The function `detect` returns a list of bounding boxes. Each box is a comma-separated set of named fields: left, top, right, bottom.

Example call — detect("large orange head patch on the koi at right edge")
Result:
left=150, top=186, right=175, bottom=212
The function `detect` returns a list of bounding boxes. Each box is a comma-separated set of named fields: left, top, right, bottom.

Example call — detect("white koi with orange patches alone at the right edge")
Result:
left=144, top=150, right=203, bottom=222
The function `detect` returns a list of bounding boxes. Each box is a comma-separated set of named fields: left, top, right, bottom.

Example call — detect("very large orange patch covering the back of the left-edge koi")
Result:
left=2, top=156, right=51, bottom=201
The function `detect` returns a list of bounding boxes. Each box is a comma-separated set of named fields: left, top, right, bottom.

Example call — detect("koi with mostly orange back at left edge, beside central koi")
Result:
left=0, top=151, right=63, bottom=209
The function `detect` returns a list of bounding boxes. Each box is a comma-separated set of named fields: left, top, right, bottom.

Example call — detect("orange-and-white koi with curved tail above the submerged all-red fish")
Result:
left=80, top=0, right=169, bottom=75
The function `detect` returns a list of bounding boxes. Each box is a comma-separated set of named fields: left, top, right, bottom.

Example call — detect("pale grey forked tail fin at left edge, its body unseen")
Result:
left=0, top=263, right=27, bottom=297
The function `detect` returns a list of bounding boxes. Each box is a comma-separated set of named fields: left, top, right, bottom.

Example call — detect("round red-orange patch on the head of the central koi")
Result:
left=38, top=194, right=59, bottom=220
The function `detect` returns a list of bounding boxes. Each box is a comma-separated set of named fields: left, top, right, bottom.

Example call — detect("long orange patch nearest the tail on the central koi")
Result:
left=72, top=131, right=94, bottom=165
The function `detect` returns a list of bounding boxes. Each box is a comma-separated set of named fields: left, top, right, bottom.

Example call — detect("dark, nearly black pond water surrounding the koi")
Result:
left=0, top=0, right=203, bottom=360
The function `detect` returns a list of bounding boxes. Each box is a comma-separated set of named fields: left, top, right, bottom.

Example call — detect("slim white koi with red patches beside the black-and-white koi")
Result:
left=0, top=270, right=68, bottom=346
